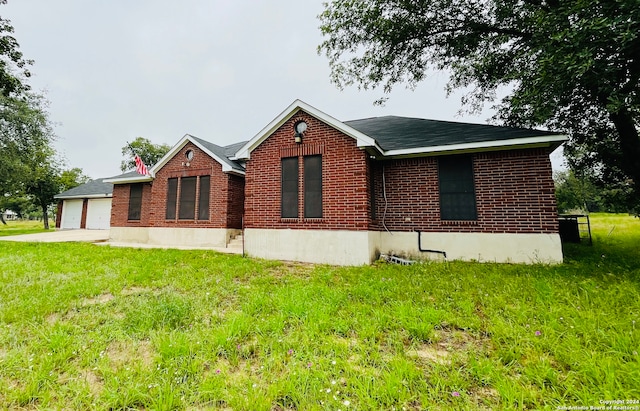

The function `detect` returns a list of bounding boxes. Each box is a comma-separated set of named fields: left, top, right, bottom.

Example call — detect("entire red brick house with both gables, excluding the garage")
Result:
left=108, top=100, right=566, bottom=265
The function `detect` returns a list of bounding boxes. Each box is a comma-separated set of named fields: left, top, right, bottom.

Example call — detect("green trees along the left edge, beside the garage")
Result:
left=0, top=0, right=89, bottom=229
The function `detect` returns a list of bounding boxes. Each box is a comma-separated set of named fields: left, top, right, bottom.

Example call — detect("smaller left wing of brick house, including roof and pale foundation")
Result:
left=106, top=134, right=244, bottom=247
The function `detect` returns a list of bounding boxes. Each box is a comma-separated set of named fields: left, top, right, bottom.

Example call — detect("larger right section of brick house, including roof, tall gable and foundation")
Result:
left=234, top=101, right=566, bottom=265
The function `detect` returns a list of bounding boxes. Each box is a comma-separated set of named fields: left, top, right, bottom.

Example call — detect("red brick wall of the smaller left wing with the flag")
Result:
left=111, top=143, right=243, bottom=228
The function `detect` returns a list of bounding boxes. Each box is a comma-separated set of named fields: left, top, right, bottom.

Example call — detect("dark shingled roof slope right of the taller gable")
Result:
left=344, top=116, right=558, bottom=151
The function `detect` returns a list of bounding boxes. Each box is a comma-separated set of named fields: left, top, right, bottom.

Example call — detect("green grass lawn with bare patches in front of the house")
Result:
left=0, top=215, right=640, bottom=411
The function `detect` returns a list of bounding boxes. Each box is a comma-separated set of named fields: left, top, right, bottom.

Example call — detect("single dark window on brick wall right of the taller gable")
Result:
left=438, top=156, right=478, bottom=220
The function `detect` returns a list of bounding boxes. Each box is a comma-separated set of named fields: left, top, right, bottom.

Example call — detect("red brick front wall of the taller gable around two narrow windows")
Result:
left=245, top=111, right=370, bottom=230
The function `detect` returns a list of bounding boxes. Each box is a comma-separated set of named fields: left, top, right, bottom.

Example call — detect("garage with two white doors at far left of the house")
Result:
left=55, top=178, right=113, bottom=230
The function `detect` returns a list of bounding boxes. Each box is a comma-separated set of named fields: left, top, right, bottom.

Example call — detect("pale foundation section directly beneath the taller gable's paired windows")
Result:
left=244, top=228, right=376, bottom=265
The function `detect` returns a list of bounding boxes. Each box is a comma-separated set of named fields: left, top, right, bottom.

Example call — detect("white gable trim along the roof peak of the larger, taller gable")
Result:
left=232, top=100, right=376, bottom=160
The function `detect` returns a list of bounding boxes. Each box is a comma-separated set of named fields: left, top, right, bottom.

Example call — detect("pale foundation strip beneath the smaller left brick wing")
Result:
left=109, top=227, right=241, bottom=248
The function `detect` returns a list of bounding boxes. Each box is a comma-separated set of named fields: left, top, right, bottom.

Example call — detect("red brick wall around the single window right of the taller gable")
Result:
left=371, top=149, right=558, bottom=233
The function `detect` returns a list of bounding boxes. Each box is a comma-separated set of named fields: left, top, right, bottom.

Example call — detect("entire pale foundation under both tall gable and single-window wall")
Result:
left=244, top=229, right=562, bottom=265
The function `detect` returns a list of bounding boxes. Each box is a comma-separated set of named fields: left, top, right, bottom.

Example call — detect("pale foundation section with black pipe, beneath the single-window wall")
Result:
left=379, top=232, right=562, bottom=264
